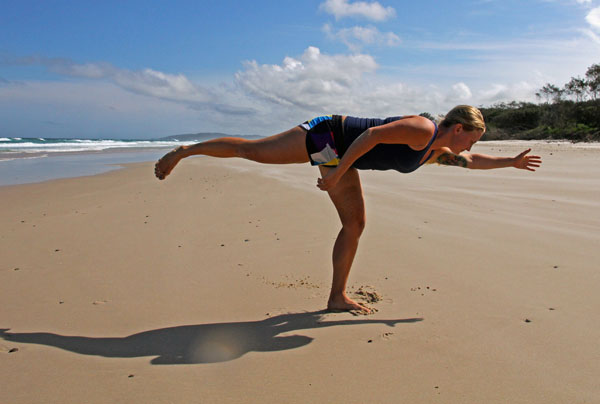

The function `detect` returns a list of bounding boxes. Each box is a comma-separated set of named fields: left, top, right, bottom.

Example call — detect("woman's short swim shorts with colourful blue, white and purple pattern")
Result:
left=300, top=115, right=342, bottom=167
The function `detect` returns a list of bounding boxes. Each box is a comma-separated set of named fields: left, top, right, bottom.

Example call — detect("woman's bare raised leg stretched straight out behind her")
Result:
left=154, top=126, right=308, bottom=180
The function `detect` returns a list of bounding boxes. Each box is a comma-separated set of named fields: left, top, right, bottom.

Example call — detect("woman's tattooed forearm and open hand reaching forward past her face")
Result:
left=435, top=149, right=542, bottom=171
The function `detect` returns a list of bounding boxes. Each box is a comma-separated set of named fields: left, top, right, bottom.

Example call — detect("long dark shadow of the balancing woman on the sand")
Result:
left=0, top=310, right=423, bottom=365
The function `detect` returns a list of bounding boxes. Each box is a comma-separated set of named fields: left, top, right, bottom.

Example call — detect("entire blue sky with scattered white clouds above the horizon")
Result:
left=0, top=0, right=600, bottom=138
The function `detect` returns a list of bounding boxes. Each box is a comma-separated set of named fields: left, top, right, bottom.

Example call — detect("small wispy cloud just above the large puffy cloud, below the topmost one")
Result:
left=323, top=24, right=400, bottom=52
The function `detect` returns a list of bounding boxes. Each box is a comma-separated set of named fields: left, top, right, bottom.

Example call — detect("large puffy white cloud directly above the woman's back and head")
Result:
left=236, top=47, right=513, bottom=118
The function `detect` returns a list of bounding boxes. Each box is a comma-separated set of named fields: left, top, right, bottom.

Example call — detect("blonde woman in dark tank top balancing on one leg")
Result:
left=154, top=105, right=542, bottom=312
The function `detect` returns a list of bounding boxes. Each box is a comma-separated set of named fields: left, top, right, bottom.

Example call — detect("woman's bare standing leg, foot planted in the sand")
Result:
left=319, top=166, right=370, bottom=312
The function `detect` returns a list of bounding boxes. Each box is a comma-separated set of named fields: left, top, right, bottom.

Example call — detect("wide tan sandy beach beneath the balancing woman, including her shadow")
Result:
left=0, top=143, right=600, bottom=404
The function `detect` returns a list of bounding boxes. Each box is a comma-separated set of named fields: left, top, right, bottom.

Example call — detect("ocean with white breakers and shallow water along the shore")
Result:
left=0, top=137, right=206, bottom=186
